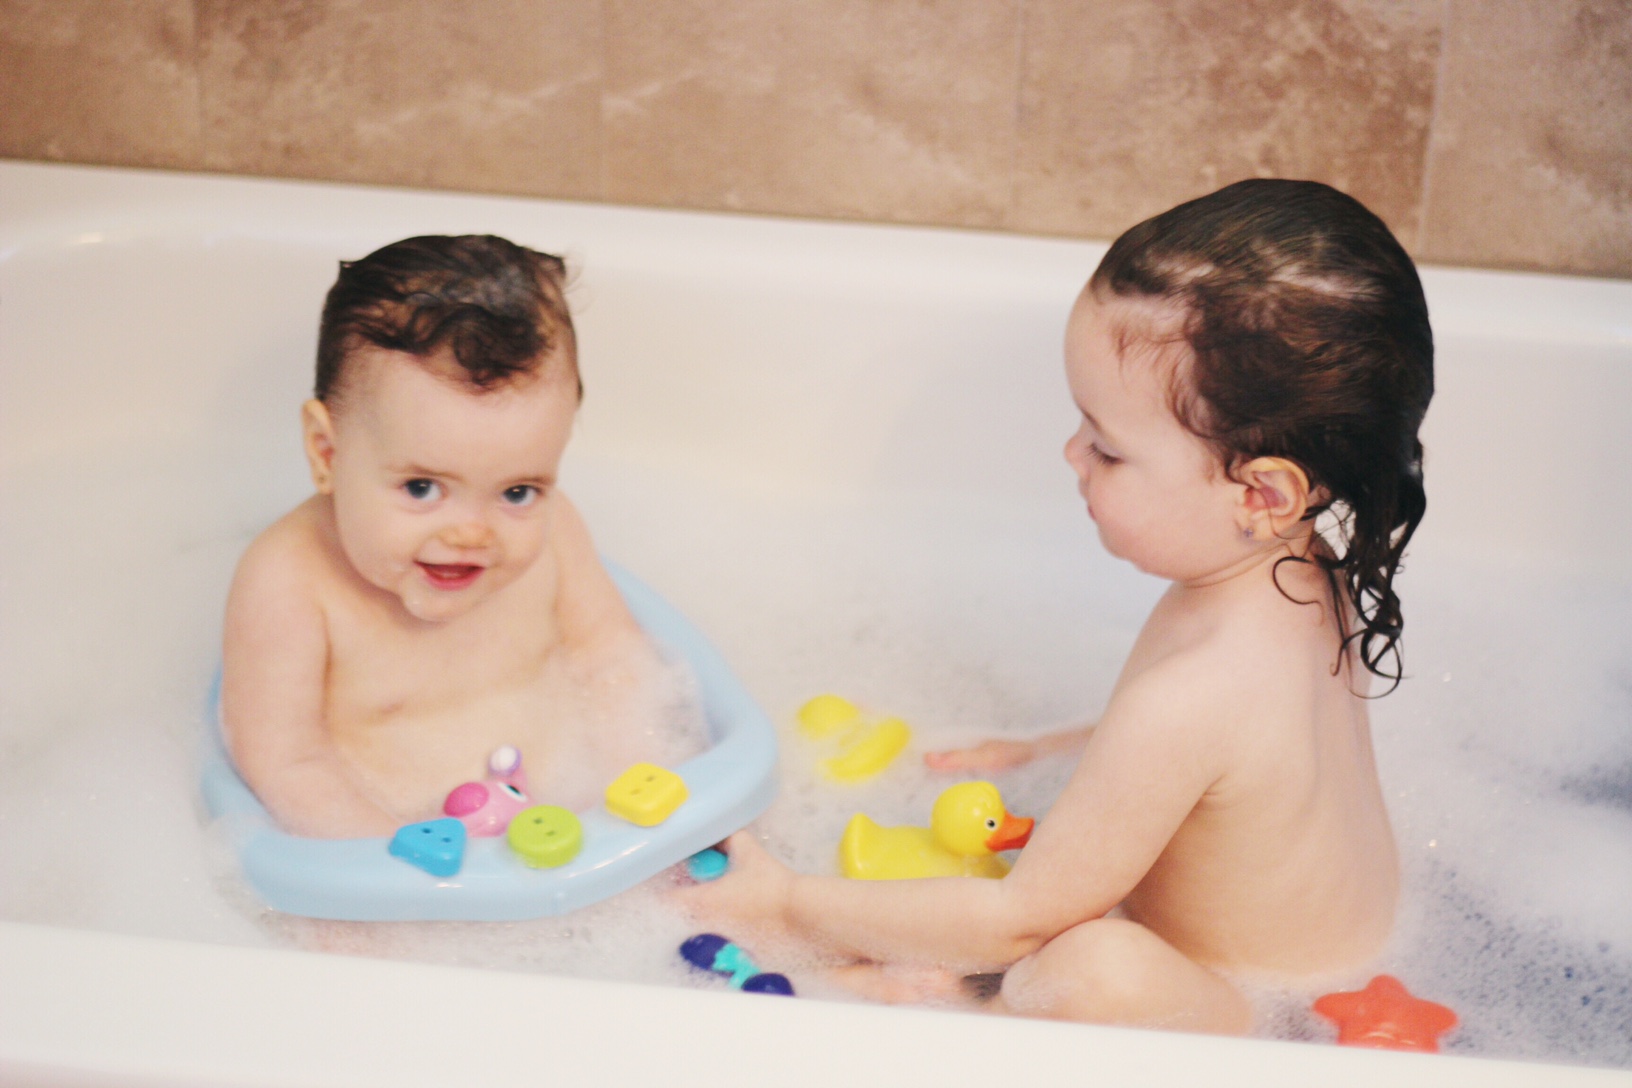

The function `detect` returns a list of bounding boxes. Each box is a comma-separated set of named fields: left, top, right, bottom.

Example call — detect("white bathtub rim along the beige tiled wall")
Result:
left=0, top=158, right=1632, bottom=346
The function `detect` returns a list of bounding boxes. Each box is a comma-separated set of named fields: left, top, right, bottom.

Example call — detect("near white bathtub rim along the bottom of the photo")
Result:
left=0, top=922, right=1632, bottom=1088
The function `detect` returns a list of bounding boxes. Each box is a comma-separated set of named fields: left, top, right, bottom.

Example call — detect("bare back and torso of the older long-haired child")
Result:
left=1116, top=564, right=1399, bottom=974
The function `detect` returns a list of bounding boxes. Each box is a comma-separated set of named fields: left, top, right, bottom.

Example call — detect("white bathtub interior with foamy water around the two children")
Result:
left=0, top=163, right=1632, bottom=1067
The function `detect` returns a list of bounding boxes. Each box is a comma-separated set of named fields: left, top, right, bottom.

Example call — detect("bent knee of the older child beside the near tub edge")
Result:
left=991, top=918, right=1252, bottom=1034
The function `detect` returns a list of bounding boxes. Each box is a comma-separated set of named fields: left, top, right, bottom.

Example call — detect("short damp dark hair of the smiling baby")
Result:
left=313, top=235, right=583, bottom=403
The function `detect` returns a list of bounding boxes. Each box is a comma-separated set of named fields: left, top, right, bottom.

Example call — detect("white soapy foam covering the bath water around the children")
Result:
left=0, top=450, right=1632, bottom=1065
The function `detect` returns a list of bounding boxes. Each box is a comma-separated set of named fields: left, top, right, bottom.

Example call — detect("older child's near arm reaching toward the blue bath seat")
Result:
left=685, top=669, right=1222, bottom=972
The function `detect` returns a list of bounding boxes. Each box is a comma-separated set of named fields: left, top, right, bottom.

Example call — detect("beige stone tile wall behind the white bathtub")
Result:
left=0, top=0, right=1632, bottom=276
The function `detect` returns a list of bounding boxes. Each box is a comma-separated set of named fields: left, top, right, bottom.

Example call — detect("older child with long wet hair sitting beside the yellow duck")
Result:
left=682, top=179, right=1433, bottom=1033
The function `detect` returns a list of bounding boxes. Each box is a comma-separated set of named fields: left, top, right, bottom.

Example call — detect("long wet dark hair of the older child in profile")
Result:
left=1089, top=178, right=1433, bottom=685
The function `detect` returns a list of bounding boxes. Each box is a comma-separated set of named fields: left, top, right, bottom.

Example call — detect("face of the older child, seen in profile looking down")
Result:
left=1066, top=292, right=1242, bottom=582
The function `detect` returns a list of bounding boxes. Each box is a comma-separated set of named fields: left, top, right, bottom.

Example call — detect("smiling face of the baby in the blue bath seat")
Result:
left=308, top=347, right=578, bottom=621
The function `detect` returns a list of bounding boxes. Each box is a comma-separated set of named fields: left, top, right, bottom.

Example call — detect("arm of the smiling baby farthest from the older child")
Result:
left=220, top=541, right=400, bottom=838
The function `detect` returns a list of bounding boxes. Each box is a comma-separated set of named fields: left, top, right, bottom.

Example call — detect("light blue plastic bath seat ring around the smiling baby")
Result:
left=202, top=568, right=777, bottom=922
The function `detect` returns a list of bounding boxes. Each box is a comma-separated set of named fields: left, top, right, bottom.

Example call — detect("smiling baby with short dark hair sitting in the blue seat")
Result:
left=220, top=237, right=674, bottom=837
